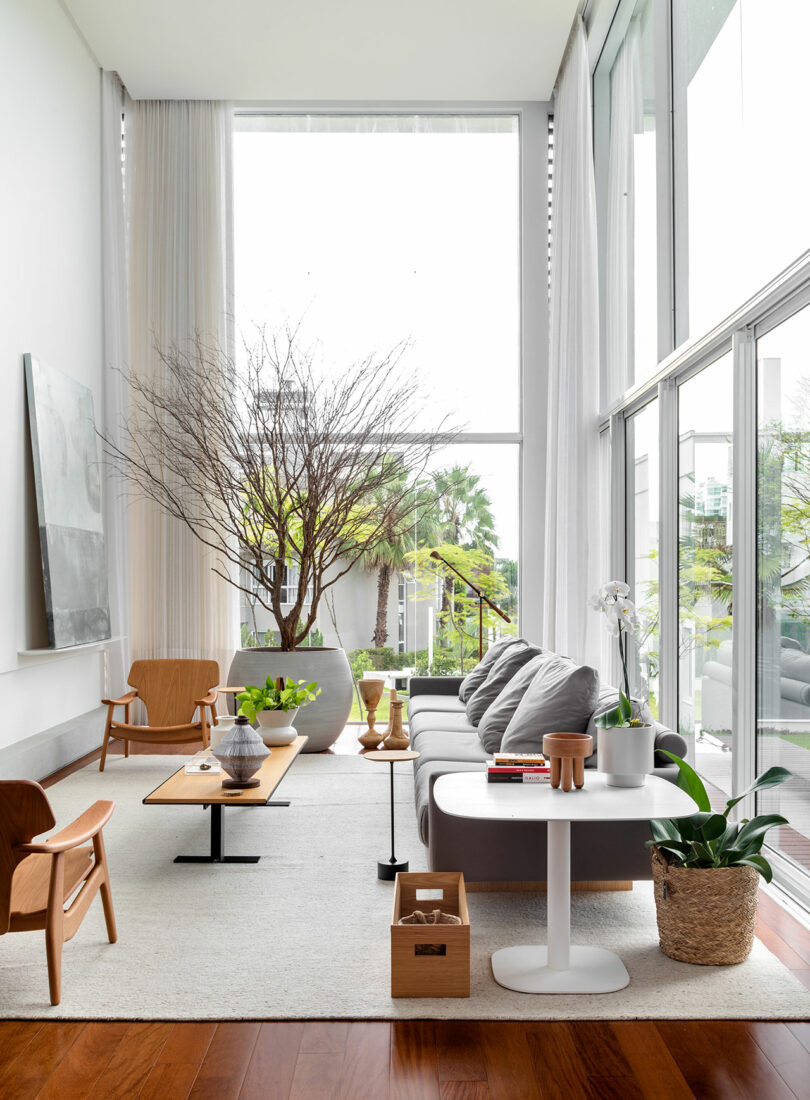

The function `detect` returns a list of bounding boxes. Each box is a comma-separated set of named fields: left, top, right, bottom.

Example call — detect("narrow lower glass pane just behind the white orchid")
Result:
left=626, top=400, right=659, bottom=717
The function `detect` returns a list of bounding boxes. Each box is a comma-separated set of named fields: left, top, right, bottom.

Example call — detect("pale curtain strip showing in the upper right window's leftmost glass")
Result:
left=605, top=20, right=644, bottom=400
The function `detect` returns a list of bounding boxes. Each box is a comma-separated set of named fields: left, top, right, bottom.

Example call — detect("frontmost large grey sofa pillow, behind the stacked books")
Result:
left=501, top=657, right=599, bottom=752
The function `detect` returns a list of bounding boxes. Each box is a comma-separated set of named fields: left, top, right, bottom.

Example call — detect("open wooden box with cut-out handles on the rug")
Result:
left=391, top=871, right=470, bottom=997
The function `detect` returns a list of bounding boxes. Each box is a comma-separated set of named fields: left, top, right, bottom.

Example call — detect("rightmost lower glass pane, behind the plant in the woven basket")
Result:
left=757, top=309, right=810, bottom=868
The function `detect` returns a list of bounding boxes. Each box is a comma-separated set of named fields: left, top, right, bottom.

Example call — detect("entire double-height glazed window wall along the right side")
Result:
left=592, top=0, right=810, bottom=901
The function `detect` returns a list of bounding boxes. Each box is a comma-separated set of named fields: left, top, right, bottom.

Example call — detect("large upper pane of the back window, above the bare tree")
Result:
left=233, top=116, right=519, bottom=431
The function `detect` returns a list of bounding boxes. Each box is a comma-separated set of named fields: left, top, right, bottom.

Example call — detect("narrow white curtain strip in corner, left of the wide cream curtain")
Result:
left=101, top=73, right=132, bottom=694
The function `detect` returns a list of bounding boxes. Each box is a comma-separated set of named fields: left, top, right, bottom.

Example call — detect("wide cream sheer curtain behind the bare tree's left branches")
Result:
left=127, top=100, right=237, bottom=677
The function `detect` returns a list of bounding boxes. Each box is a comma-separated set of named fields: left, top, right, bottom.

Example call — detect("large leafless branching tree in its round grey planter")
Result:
left=105, top=330, right=453, bottom=752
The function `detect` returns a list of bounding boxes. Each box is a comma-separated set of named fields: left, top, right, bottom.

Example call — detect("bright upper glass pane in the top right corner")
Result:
left=672, top=0, right=810, bottom=337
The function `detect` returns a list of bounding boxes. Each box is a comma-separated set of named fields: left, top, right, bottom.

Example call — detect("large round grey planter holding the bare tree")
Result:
left=228, top=646, right=353, bottom=752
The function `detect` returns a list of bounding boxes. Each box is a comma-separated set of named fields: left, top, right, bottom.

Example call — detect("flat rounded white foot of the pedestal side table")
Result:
left=492, top=946, right=630, bottom=993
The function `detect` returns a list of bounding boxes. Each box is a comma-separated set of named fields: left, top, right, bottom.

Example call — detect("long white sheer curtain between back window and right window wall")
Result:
left=543, top=19, right=601, bottom=666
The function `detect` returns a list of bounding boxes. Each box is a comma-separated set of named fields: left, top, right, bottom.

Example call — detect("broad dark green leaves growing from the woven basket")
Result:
left=647, top=750, right=792, bottom=882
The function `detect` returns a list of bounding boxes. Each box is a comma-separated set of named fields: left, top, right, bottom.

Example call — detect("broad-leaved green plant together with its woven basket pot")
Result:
left=647, top=752, right=791, bottom=966
